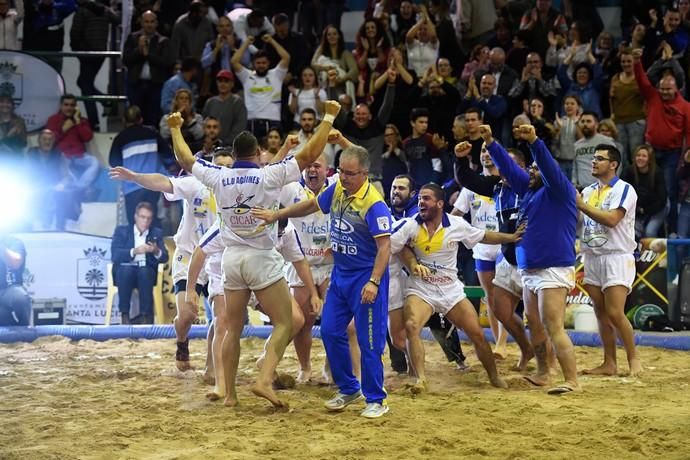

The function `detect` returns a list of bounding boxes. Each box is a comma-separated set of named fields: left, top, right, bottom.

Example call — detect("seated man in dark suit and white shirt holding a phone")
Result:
left=110, top=201, right=168, bottom=324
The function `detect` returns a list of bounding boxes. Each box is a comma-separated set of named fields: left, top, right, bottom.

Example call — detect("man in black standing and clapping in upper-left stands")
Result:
left=122, top=11, right=173, bottom=126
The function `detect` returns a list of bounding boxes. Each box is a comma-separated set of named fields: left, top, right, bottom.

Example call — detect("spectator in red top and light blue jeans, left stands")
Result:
left=46, top=94, right=100, bottom=195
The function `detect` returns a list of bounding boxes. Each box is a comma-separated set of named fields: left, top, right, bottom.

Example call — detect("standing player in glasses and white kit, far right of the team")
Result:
left=577, top=144, right=642, bottom=377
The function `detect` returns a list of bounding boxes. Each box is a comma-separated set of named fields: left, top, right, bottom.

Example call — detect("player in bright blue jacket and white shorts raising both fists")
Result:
left=480, top=125, right=579, bottom=394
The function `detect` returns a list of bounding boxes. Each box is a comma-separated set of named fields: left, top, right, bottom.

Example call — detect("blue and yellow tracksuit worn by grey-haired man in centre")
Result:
left=317, top=181, right=391, bottom=403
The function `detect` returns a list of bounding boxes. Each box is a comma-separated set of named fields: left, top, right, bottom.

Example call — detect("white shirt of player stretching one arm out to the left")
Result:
left=163, top=176, right=216, bottom=254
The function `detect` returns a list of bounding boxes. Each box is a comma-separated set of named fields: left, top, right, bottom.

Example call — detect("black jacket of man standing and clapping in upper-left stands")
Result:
left=122, top=31, right=175, bottom=85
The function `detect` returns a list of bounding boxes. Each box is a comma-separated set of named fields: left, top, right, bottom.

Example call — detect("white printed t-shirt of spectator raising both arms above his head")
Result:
left=235, top=64, right=288, bottom=121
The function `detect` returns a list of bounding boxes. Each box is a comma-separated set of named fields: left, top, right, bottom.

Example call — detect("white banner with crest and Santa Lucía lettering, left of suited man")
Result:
left=15, top=232, right=111, bottom=324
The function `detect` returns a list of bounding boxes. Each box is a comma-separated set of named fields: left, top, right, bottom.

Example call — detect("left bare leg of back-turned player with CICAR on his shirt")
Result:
left=221, top=289, right=250, bottom=406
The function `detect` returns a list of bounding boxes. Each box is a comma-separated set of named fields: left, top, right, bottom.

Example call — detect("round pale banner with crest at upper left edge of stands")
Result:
left=0, top=50, right=65, bottom=132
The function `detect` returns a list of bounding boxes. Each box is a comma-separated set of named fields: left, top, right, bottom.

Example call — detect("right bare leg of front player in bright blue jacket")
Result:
left=538, top=288, right=579, bottom=390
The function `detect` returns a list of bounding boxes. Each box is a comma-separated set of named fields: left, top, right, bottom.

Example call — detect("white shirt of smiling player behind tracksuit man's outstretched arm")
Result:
left=280, top=174, right=338, bottom=266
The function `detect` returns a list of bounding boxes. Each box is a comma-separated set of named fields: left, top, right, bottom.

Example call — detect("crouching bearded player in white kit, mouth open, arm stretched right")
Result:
left=391, top=183, right=520, bottom=394
